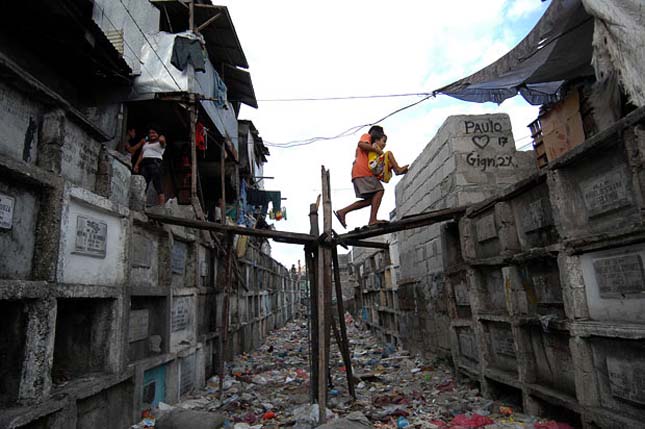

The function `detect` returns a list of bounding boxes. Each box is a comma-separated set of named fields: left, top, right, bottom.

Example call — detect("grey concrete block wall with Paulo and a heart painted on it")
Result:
left=396, top=114, right=535, bottom=356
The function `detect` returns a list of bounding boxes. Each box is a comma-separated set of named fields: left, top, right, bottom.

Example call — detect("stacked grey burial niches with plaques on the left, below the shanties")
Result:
left=0, top=100, right=299, bottom=428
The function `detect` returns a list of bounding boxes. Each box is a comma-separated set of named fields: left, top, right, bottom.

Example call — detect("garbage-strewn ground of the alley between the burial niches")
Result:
left=139, top=314, right=571, bottom=429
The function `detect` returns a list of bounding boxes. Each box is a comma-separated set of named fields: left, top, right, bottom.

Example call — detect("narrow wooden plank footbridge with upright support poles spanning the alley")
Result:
left=146, top=166, right=466, bottom=424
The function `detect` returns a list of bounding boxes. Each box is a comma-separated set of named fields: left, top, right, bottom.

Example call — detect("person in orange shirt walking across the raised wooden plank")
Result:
left=334, top=125, right=387, bottom=228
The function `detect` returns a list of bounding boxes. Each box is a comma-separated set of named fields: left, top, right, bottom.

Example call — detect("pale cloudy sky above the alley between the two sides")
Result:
left=216, top=0, right=549, bottom=267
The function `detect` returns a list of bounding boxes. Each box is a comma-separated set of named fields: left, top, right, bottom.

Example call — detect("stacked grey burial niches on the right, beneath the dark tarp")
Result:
left=446, top=109, right=645, bottom=428
